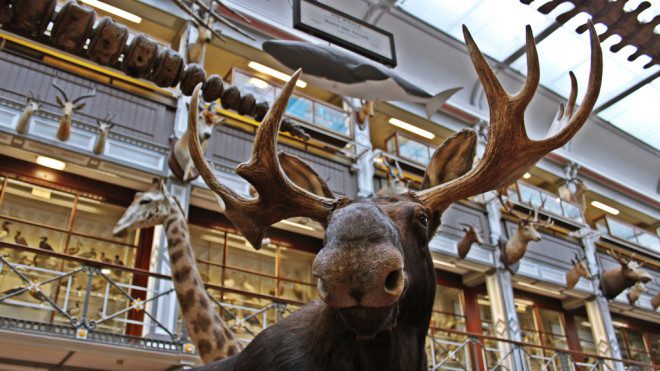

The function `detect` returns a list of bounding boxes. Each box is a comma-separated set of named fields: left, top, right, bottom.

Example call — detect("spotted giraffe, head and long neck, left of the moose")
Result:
left=112, top=180, right=243, bottom=363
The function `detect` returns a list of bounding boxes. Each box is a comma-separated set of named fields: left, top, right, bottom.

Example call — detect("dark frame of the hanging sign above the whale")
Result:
left=293, top=0, right=397, bottom=67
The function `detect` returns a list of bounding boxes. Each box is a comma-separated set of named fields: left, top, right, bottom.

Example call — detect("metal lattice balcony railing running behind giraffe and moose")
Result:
left=0, top=242, right=653, bottom=370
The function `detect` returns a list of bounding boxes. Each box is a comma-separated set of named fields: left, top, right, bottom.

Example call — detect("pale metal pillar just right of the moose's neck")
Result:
left=486, top=196, right=526, bottom=370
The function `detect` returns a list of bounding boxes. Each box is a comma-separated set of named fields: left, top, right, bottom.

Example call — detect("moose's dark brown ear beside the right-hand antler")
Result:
left=422, top=129, right=477, bottom=189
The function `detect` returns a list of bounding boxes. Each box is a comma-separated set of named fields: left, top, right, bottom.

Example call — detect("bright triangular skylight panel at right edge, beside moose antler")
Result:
left=598, top=78, right=660, bottom=151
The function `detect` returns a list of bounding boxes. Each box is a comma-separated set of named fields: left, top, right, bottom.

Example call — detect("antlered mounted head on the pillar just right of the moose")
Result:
left=499, top=198, right=554, bottom=274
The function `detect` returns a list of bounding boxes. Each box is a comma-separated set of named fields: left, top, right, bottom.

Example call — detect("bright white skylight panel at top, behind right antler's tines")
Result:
left=396, top=0, right=556, bottom=62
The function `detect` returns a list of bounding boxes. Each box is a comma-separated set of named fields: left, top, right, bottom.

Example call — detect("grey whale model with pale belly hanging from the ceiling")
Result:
left=262, top=40, right=462, bottom=119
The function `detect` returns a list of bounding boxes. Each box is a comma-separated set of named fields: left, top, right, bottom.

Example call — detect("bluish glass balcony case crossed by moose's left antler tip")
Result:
left=231, top=68, right=353, bottom=139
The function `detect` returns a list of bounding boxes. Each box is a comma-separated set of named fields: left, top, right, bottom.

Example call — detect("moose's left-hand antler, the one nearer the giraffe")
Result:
left=188, top=70, right=336, bottom=249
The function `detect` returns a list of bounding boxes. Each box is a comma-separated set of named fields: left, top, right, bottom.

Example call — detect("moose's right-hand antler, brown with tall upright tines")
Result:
left=414, top=23, right=603, bottom=214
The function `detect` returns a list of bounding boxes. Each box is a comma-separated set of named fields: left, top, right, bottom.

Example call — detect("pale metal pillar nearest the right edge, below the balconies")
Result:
left=580, top=231, right=624, bottom=371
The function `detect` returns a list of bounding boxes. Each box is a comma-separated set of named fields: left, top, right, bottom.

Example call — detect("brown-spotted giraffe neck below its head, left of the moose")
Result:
left=164, top=201, right=243, bottom=363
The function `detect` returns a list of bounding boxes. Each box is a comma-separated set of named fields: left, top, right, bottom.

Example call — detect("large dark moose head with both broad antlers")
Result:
left=188, top=27, right=602, bottom=344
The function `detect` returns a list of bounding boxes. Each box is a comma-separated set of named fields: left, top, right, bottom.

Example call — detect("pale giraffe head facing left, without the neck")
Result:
left=112, top=179, right=172, bottom=235
